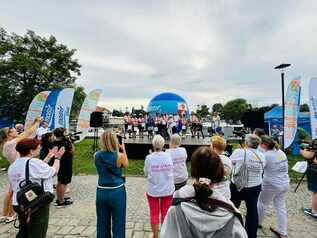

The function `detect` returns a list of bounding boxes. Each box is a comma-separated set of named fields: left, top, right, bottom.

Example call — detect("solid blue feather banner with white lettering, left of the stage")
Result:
left=42, top=89, right=61, bottom=130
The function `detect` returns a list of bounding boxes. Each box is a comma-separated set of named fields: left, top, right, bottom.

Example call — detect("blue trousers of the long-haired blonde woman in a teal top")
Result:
left=96, top=186, right=127, bottom=238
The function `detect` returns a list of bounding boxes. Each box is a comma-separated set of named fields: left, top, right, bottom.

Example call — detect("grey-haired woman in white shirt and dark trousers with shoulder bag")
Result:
left=230, top=134, right=265, bottom=238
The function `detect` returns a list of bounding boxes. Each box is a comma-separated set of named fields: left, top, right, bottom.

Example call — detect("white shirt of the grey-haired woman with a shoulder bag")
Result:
left=230, top=148, right=265, bottom=188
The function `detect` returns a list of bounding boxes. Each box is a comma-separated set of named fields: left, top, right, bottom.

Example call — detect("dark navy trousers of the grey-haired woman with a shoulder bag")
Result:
left=230, top=183, right=261, bottom=238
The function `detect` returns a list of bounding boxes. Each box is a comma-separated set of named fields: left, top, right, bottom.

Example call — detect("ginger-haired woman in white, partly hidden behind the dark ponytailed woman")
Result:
left=211, top=136, right=232, bottom=199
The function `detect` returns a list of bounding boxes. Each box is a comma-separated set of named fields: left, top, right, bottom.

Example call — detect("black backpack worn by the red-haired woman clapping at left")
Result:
left=17, top=159, right=54, bottom=222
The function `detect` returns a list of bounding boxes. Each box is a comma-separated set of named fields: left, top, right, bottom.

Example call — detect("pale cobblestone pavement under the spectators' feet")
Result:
left=0, top=173, right=317, bottom=238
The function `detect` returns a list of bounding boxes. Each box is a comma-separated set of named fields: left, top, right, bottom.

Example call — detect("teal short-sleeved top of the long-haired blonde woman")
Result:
left=95, top=151, right=124, bottom=187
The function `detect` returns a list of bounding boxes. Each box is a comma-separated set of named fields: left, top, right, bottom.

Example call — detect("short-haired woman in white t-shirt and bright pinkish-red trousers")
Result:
left=144, top=135, right=175, bottom=238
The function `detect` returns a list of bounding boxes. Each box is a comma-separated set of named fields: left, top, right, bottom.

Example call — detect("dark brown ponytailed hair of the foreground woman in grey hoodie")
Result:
left=191, top=146, right=224, bottom=212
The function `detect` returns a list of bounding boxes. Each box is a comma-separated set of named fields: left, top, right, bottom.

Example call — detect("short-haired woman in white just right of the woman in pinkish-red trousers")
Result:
left=166, top=134, right=188, bottom=190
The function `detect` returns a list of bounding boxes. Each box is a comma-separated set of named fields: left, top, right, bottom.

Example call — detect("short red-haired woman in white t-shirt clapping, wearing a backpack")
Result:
left=8, top=138, right=65, bottom=238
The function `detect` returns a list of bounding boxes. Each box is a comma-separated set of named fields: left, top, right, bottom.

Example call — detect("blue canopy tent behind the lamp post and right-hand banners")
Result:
left=264, top=106, right=311, bottom=155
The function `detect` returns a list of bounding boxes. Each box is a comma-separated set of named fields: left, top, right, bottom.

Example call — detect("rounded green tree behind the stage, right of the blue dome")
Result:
left=223, top=98, right=249, bottom=122
